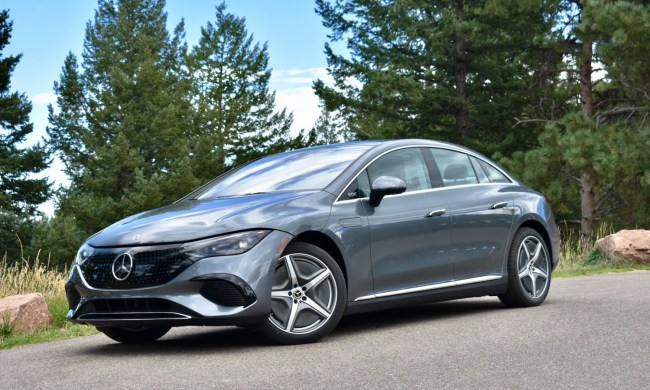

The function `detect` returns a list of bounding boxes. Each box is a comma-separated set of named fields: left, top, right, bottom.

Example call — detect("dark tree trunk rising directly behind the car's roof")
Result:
left=454, top=0, right=469, bottom=143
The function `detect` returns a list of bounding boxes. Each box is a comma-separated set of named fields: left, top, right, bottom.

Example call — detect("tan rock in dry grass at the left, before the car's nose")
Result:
left=0, top=293, right=53, bottom=331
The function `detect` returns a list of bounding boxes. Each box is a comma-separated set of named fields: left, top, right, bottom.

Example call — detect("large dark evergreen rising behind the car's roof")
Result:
left=314, top=0, right=554, bottom=152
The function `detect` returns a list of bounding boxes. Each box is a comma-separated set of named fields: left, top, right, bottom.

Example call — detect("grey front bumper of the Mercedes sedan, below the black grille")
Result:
left=66, top=231, right=292, bottom=326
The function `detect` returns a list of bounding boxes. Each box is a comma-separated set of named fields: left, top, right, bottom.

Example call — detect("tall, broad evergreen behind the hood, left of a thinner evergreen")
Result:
left=46, top=0, right=199, bottom=261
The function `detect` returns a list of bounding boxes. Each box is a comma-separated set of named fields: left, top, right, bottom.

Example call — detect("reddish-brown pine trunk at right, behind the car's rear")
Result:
left=580, top=35, right=596, bottom=253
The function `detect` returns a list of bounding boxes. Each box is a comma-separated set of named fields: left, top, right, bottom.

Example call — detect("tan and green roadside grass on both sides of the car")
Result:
left=0, top=231, right=650, bottom=350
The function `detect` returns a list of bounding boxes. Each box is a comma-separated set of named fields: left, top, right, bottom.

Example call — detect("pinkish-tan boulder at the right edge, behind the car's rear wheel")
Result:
left=596, top=230, right=650, bottom=264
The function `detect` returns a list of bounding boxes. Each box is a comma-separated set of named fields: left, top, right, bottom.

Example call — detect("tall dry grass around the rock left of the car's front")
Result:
left=0, top=255, right=97, bottom=350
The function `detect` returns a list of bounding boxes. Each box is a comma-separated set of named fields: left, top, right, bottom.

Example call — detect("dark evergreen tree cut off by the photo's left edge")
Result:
left=0, top=10, right=49, bottom=259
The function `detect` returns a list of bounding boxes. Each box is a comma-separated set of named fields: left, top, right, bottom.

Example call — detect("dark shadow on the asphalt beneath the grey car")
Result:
left=78, top=298, right=505, bottom=356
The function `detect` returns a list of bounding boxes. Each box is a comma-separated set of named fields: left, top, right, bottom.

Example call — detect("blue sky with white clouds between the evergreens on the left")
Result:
left=6, top=0, right=334, bottom=214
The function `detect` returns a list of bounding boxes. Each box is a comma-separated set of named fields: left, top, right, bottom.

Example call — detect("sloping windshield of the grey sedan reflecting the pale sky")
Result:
left=197, top=143, right=373, bottom=199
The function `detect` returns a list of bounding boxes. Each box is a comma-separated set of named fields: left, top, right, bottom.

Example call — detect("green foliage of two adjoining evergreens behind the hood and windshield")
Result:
left=41, top=0, right=300, bottom=265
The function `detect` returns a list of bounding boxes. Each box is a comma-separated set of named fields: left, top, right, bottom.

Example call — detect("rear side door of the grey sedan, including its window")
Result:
left=429, top=148, right=514, bottom=281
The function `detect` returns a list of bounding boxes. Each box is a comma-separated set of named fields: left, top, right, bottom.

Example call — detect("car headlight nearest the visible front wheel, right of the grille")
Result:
left=180, top=230, right=271, bottom=260
